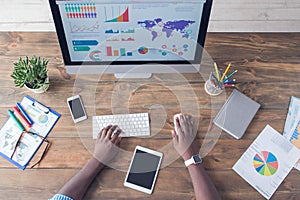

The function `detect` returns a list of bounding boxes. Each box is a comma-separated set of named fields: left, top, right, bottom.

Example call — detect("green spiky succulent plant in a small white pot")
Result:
left=11, top=56, right=50, bottom=93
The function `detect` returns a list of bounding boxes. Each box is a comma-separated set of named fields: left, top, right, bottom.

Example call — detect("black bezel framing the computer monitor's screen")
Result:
left=49, top=0, right=213, bottom=67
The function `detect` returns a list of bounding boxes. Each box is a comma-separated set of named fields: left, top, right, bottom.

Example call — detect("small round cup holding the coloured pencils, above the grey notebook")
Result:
left=204, top=72, right=225, bottom=96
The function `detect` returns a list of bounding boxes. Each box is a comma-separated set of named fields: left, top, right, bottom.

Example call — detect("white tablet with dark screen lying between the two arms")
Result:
left=124, top=146, right=163, bottom=194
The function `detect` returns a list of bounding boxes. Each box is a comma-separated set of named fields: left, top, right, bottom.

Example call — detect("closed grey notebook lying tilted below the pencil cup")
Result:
left=213, top=89, right=260, bottom=139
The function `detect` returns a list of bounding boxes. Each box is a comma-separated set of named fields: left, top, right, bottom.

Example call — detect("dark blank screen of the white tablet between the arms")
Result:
left=126, top=149, right=161, bottom=190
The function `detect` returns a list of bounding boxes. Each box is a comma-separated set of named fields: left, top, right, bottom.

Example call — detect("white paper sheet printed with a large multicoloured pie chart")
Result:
left=233, top=125, right=300, bottom=199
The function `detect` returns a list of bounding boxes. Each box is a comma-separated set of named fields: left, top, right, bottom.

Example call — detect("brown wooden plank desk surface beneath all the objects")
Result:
left=0, top=33, right=300, bottom=200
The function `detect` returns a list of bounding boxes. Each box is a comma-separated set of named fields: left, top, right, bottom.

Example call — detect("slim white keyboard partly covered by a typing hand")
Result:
left=93, top=113, right=150, bottom=139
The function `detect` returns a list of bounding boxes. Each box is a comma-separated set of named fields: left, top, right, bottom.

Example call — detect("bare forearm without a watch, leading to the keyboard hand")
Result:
left=59, top=158, right=104, bottom=200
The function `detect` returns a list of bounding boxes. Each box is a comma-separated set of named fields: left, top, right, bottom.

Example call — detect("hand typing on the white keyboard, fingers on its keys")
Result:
left=93, top=125, right=121, bottom=165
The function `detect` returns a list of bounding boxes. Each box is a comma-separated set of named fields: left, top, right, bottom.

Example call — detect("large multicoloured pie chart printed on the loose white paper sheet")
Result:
left=253, top=151, right=278, bottom=176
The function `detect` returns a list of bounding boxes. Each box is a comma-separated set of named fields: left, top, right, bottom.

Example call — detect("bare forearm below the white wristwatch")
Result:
left=188, top=164, right=220, bottom=200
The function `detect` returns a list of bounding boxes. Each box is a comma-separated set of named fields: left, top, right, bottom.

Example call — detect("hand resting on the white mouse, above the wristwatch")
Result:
left=172, top=114, right=197, bottom=160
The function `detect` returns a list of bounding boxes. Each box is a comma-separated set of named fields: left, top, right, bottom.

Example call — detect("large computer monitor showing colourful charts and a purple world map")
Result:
left=49, top=0, right=212, bottom=77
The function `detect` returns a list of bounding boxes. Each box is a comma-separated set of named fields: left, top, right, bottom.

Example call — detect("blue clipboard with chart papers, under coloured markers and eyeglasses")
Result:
left=0, top=95, right=61, bottom=170
